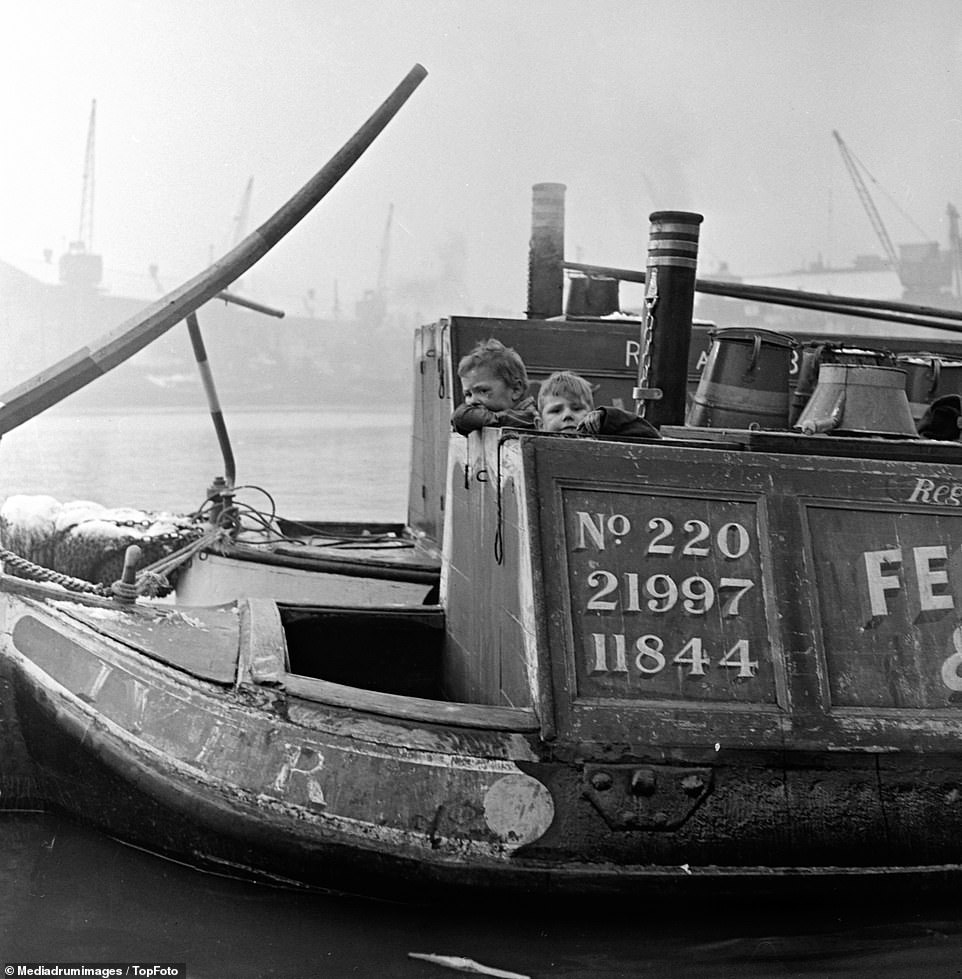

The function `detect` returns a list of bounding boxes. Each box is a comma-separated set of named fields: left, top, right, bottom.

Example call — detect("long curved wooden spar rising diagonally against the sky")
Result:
left=0, top=65, right=427, bottom=435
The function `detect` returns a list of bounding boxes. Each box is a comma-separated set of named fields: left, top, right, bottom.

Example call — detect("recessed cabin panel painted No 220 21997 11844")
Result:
left=565, top=490, right=774, bottom=702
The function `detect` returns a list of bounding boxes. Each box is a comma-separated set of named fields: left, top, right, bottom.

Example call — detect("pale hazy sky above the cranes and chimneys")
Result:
left=0, top=0, right=962, bottom=316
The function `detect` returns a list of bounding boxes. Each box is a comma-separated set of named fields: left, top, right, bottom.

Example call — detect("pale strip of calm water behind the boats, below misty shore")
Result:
left=0, top=408, right=411, bottom=520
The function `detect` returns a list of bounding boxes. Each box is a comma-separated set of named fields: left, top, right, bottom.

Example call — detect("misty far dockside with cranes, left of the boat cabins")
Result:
left=0, top=101, right=463, bottom=409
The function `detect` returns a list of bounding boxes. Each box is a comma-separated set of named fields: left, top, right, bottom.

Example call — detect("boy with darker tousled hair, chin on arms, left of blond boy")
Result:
left=451, top=339, right=538, bottom=435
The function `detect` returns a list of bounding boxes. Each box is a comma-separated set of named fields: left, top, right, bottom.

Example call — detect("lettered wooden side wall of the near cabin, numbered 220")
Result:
left=525, top=436, right=962, bottom=750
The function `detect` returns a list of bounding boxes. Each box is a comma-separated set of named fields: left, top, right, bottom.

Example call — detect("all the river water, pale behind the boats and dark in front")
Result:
left=0, top=408, right=962, bottom=979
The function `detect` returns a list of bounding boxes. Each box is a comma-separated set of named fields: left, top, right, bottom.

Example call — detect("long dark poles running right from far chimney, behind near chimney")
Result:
left=563, top=261, right=962, bottom=333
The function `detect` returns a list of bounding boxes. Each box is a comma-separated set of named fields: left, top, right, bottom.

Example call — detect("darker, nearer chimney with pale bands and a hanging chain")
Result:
left=635, top=211, right=704, bottom=427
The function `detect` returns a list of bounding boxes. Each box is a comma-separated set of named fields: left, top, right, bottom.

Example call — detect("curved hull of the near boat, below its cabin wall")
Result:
left=0, top=580, right=962, bottom=900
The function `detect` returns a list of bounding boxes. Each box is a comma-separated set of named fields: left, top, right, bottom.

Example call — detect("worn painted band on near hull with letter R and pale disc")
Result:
left=8, top=609, right=550, bottom=859
